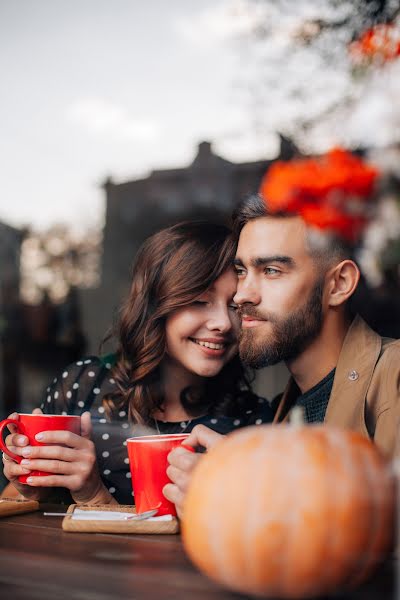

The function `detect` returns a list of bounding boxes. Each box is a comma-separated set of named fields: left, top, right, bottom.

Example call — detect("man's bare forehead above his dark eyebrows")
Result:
left=236, top=216, right=307, bottom=258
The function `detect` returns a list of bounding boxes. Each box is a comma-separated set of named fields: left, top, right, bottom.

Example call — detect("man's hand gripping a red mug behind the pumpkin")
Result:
left=163, top=425, right=223, bottom=517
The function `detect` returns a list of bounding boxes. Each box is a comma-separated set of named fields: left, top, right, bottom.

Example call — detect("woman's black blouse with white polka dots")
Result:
left=41, top=356, right=273, bottom=504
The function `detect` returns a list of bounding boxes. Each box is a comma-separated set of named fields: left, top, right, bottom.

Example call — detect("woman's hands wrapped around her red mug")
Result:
left=5, top=412, right=116, bottom=504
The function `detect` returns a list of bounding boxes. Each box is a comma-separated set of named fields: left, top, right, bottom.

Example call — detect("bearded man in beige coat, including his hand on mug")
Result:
left=164, top=164, right=400, bottom=511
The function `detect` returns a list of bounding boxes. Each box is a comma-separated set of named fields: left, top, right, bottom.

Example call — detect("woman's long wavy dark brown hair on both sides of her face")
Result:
left=103, top=221, right=257, bottom=424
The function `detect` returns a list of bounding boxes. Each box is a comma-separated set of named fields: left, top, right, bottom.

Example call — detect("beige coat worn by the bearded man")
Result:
left=274, top=316, right=400, bottom=457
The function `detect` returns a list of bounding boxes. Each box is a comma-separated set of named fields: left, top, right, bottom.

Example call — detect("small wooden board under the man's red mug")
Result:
left=62, top=504, right=179, bottom=534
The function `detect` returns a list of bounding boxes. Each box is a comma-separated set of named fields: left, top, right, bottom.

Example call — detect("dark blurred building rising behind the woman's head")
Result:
left=82, top=138, right=297, bottom=398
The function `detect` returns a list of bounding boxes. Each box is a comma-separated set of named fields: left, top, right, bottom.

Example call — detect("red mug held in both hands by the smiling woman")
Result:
left=0, top=413, right=81, bottom=483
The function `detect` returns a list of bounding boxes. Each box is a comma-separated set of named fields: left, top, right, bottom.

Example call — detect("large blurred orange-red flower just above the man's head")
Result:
left=260, top=148, right=378, bottom=241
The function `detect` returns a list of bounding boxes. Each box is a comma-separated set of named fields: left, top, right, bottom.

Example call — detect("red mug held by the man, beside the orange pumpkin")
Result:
left=127, top=433, right=192, bottom=516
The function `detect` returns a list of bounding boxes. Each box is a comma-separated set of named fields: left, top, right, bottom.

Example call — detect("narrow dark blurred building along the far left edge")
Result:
left=0, top=223, right=24, bottom=417
